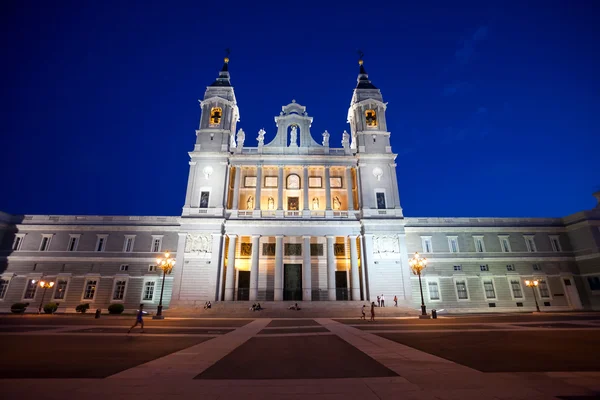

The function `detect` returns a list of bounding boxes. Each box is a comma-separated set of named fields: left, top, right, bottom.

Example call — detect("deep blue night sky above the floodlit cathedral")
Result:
left=0, top=0, right=600, bottom=217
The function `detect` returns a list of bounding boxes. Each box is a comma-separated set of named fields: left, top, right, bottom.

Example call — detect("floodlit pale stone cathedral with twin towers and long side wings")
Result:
left=0, top=58, right=600, bottom=313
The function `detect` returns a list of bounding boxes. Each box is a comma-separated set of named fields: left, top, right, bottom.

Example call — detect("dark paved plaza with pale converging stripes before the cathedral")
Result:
left=0, top=314, right=600, bottom=400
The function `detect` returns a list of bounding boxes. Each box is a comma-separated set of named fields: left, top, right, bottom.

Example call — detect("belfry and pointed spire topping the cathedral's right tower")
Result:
left=348, top=54, right=391, bottom=153
